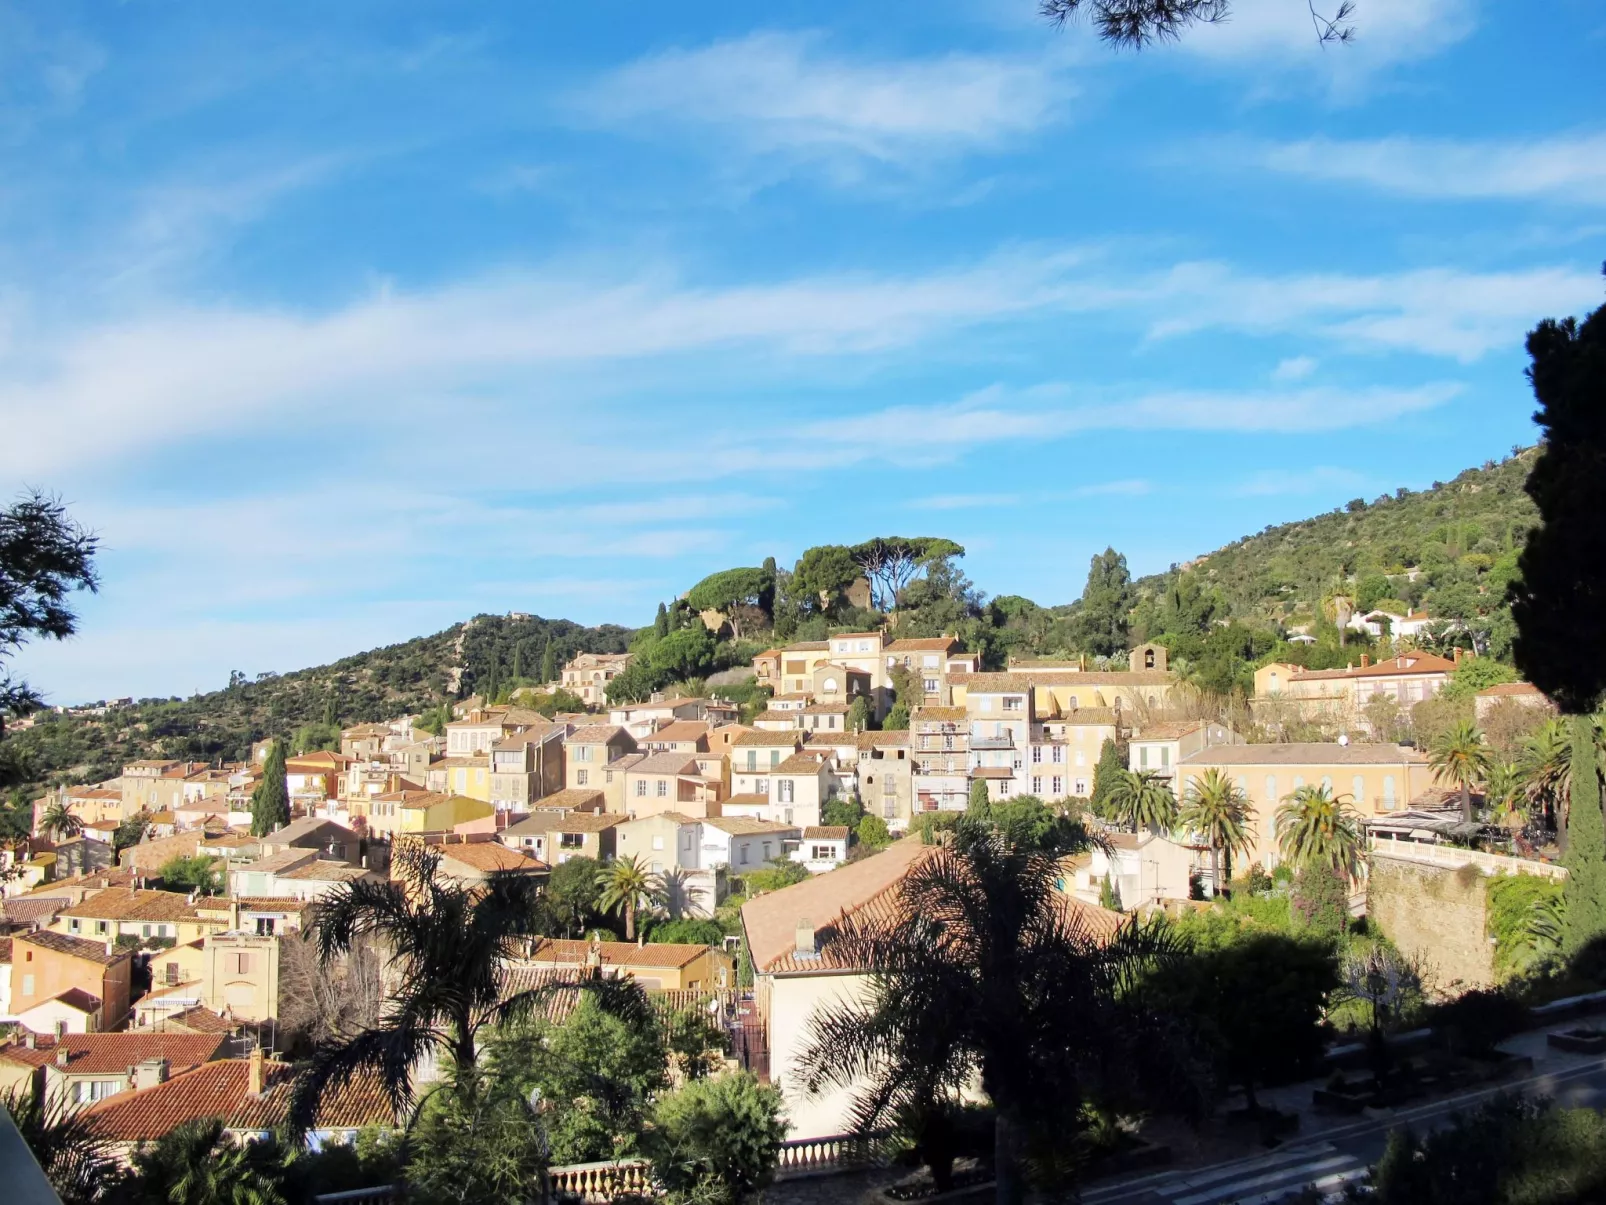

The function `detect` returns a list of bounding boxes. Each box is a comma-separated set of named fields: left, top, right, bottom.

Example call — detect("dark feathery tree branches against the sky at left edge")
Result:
left=0, top=490, right=100, bottom=755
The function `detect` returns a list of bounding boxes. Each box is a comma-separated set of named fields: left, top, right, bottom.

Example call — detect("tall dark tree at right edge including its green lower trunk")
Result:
left=1510, top=290, right=1606, bottom=953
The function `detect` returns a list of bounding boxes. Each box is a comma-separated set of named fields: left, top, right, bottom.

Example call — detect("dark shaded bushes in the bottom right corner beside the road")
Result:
left=1368, top=1096, right=1606, bottom=1205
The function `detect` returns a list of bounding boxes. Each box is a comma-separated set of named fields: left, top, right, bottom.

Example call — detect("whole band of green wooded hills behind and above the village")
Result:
left=0, top=448, right=1535, bottom=803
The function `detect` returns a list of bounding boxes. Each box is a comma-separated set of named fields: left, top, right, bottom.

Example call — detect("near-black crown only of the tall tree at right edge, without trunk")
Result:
left=1511, top=305, right=1606, bottom=715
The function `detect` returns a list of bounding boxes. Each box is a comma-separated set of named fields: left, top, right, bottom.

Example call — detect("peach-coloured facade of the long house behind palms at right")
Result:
left=1177, top=742, right=1433, bottom=869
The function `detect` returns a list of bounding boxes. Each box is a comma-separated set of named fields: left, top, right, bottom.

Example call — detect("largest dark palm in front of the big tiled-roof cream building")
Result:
left=798, top=824, right=1196, bottom=1203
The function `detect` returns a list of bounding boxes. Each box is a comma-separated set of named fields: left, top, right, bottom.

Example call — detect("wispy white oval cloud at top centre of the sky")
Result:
left=577, top=32, right=1070, bottom=177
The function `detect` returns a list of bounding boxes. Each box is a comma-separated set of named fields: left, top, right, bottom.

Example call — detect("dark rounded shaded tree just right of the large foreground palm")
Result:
left=1150, top=933, right=1338, bottom=1109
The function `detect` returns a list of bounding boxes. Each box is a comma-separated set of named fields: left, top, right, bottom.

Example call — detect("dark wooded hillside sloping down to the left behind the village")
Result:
left=0, top=615, right=631, bottom=787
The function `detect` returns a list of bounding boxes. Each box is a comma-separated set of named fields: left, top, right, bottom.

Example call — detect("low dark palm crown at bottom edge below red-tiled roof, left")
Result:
left=127, top=1117, right=286, bottom=1205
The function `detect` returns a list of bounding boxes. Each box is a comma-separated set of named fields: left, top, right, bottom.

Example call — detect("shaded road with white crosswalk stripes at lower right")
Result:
left=1082, top=1059, right=1606, bottom=1205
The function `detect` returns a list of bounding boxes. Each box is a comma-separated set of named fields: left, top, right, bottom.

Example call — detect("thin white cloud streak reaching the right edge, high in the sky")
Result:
left=1254, top=133, right=1606, bottom=206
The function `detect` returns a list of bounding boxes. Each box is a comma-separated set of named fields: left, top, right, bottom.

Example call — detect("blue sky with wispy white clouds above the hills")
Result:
left=0, top=0, right=1606, bottom=702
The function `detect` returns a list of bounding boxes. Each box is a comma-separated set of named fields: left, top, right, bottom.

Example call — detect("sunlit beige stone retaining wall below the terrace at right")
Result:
left=1367, top=852, right=1495, bottom=991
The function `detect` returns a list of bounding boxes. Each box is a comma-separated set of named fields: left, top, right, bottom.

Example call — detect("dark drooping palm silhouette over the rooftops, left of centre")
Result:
left=291, top=842, right=650, bottom=1133
